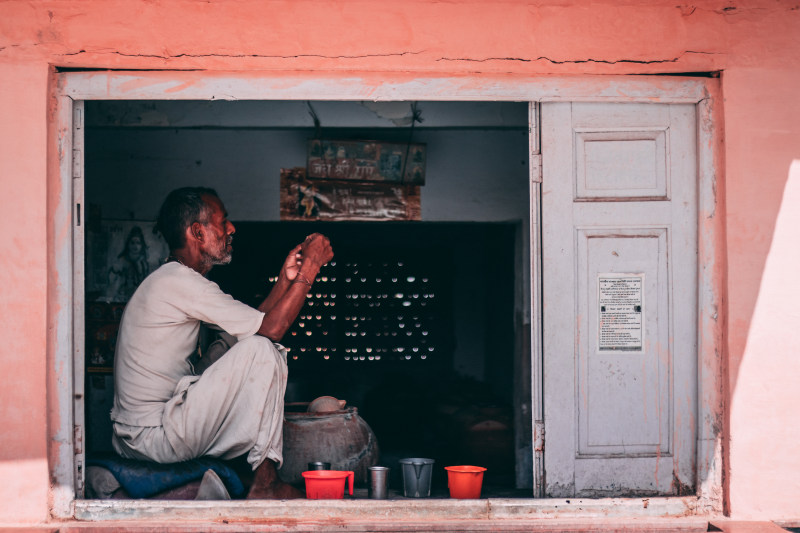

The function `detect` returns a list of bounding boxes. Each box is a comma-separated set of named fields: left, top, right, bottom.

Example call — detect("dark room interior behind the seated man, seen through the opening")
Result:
left=85, top=98, right=531, bottom=497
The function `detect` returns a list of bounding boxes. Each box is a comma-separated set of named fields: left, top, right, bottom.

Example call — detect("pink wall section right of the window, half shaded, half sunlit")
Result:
left=724, top=65, right=800, bottom=518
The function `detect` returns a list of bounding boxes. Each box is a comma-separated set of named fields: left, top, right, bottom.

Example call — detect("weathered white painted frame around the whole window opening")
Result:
left=48, top=71, right=727, bottom=520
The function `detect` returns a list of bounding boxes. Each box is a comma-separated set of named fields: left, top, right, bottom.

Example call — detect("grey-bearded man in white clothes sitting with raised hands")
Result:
left=111, top=187, right=333, bottom=499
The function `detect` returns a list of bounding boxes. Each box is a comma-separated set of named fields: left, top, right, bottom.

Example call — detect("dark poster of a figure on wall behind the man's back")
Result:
left=86, top=220, right=169, bottom=303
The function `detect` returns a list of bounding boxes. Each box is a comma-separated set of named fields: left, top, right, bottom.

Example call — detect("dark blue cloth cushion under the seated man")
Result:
left=86, top=456, right=244, bottom=498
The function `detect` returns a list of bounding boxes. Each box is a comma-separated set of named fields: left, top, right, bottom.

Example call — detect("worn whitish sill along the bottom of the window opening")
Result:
left=74, top=497, right=705, bottom=524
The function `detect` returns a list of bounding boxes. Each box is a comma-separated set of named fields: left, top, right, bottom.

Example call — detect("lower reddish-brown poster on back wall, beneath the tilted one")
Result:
left=281, top=167, right=421, bottom=220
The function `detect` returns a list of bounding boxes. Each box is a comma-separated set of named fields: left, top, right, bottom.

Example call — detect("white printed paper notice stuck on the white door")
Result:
left=597, top=274, right=644, bottom=352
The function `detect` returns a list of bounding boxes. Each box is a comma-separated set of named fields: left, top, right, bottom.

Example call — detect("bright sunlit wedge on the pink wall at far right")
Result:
left=728, top=160, right=800, bottom=517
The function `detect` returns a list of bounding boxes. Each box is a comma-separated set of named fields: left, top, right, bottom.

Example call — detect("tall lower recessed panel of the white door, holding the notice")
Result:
left=577, top=228, right=671, bottom=457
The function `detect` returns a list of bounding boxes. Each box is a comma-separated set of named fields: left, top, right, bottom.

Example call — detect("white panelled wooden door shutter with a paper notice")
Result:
left=541, top=103, right=697, bottom=497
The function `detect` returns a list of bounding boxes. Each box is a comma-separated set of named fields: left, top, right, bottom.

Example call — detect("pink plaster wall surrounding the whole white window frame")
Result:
left=0, top=0, right=800, bottom=523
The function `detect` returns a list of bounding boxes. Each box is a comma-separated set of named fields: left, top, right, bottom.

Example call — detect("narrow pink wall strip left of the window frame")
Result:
left=0, top=64, right=48, bottom=521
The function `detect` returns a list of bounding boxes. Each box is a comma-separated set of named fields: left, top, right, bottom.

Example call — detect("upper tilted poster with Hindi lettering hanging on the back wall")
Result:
left=306, top=139, right=425, bottom=185
